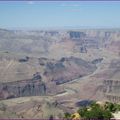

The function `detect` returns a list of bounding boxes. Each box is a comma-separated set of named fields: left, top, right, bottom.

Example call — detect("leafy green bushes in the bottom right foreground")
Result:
left=65, top=102, right=120, bottom=119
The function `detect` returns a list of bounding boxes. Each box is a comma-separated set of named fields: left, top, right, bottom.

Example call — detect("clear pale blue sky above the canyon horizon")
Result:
left=0, top=1, right=120, bottom=28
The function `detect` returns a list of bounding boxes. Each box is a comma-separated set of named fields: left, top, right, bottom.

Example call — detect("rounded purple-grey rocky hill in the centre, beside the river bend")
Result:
left=44, top=57, right=96, bottom=85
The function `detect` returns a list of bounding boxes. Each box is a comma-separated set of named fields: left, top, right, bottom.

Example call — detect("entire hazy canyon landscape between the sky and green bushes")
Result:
left=0, top=29, right=120, bottom=118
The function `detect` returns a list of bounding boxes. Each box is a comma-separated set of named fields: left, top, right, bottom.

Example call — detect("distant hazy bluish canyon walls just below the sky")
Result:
left=0, top=29, right=120, bottom=55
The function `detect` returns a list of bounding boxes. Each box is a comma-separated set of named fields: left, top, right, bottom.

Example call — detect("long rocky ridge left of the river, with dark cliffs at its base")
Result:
left=0, top=53, right=97, bottom=99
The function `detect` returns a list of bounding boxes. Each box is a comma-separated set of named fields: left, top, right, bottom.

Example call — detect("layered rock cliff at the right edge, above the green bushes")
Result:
left=98, top=59, right=120, bottom=102
